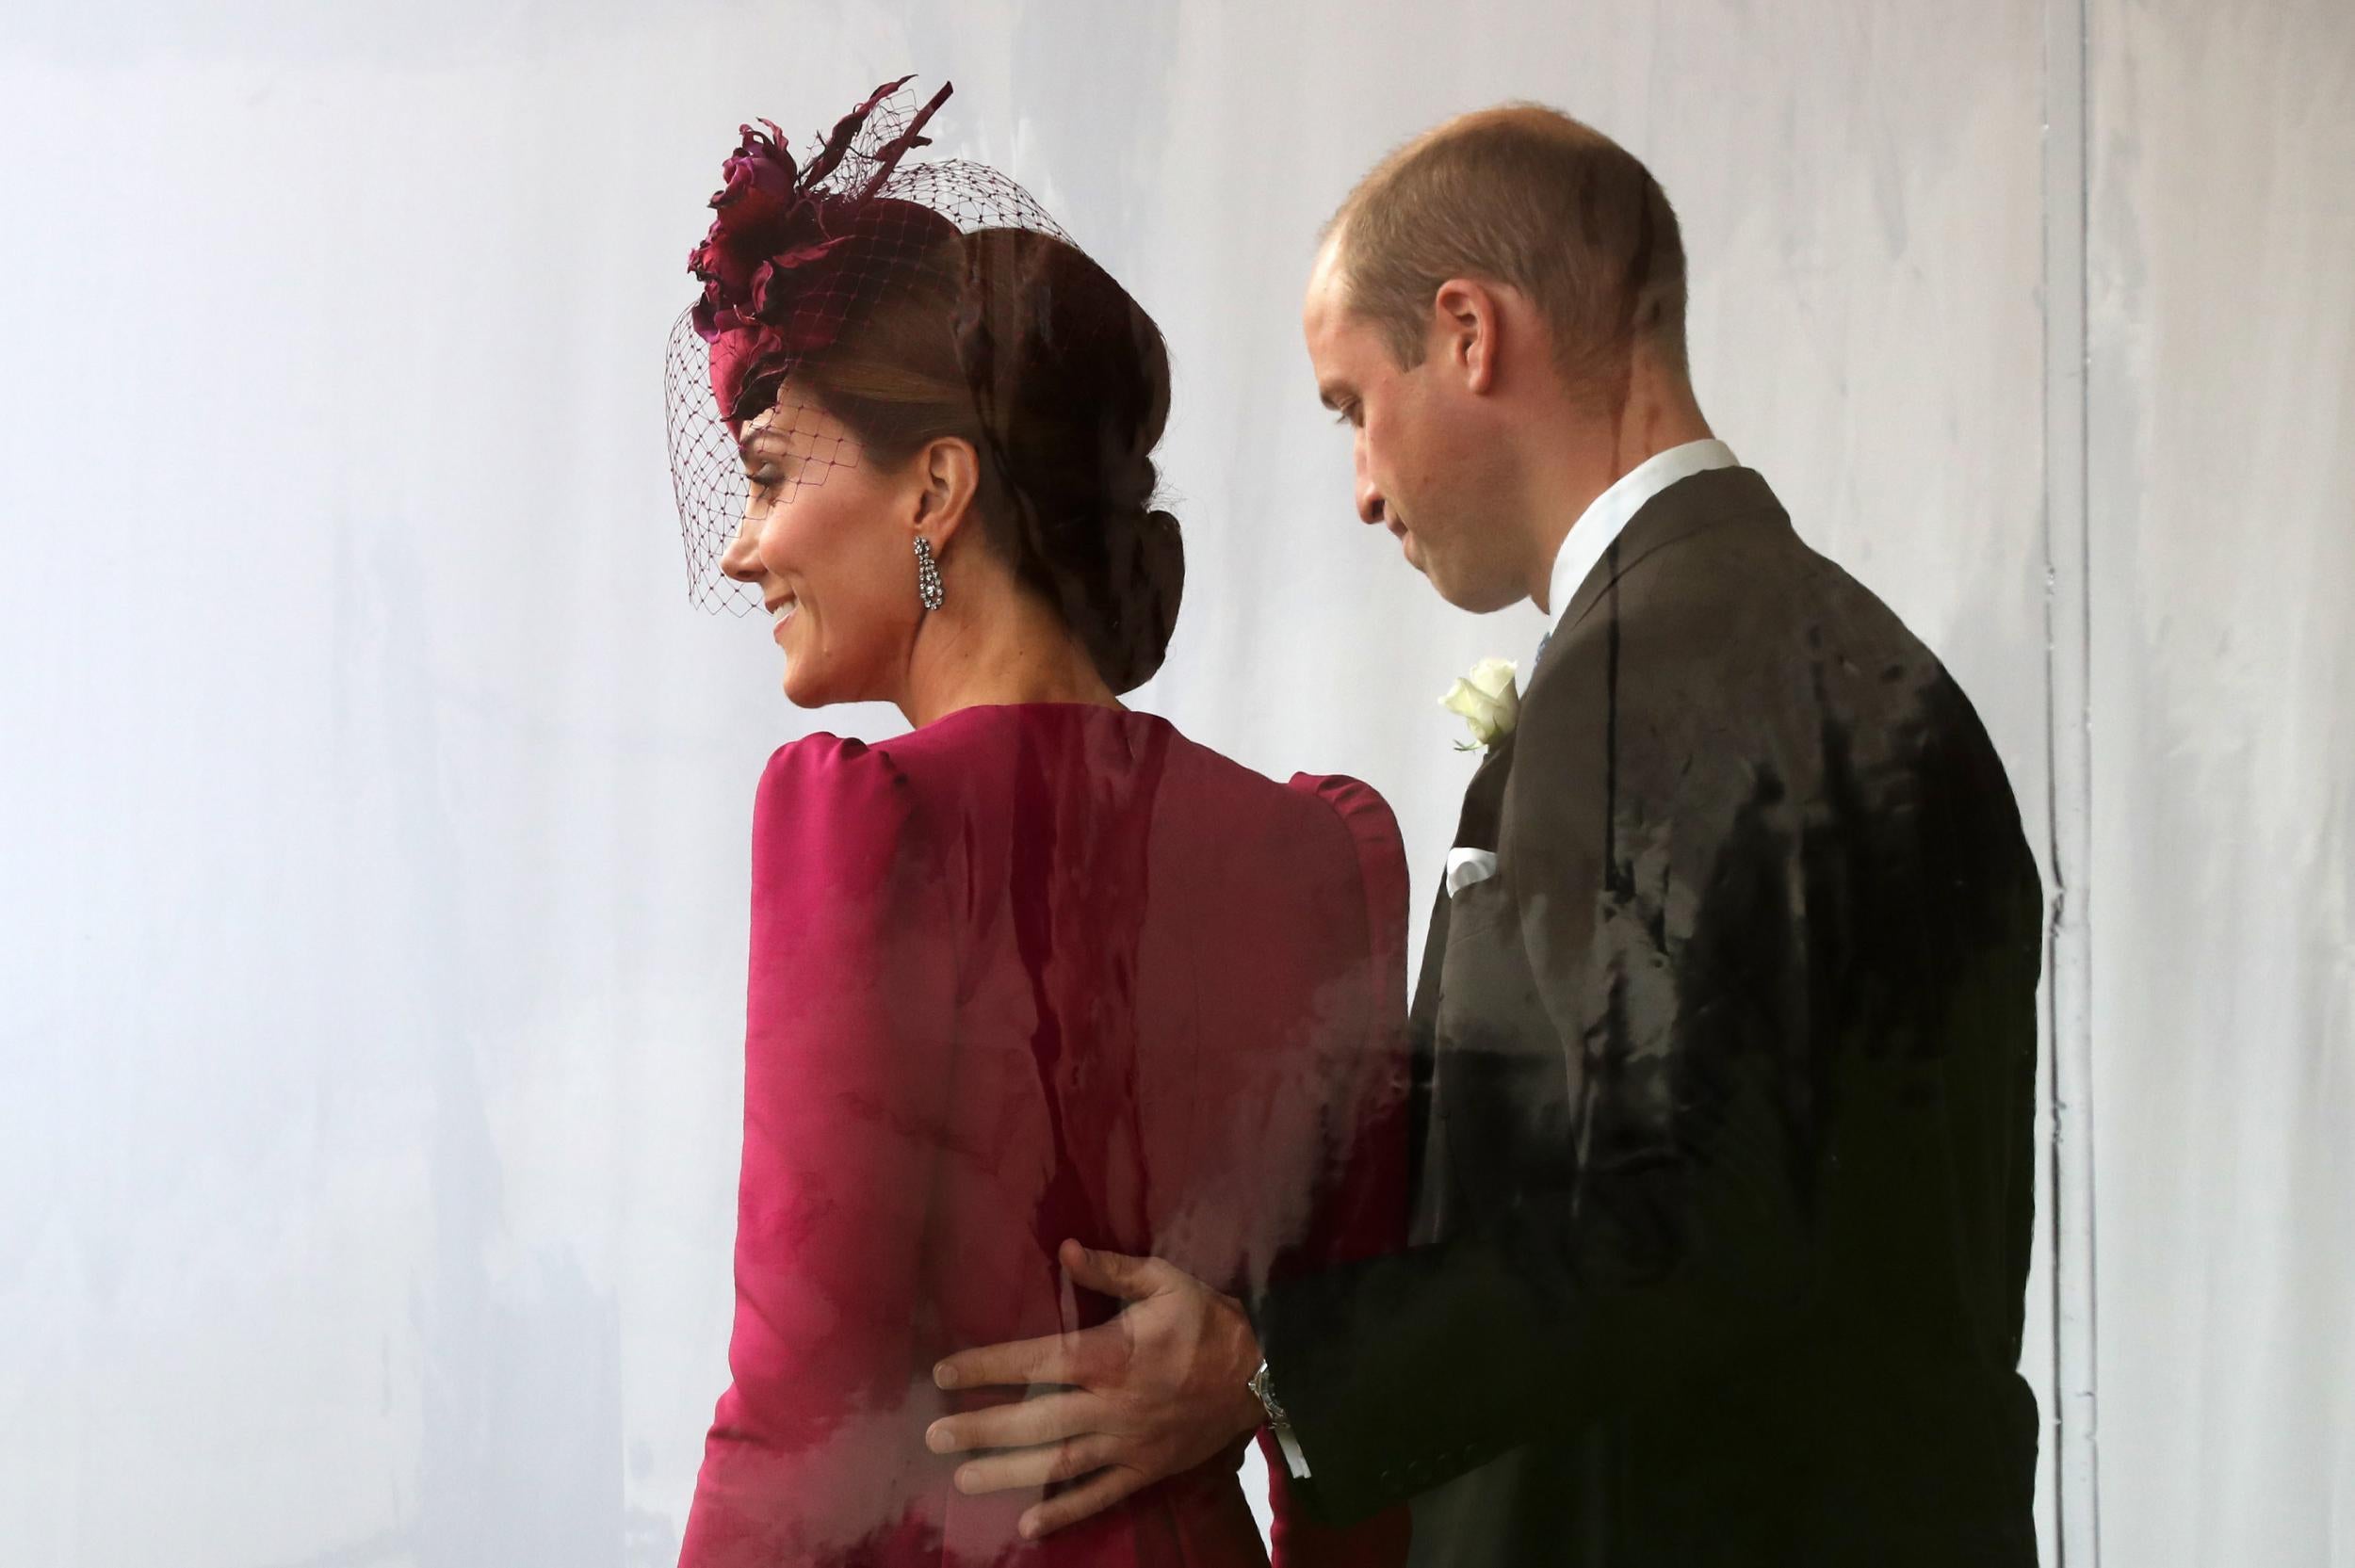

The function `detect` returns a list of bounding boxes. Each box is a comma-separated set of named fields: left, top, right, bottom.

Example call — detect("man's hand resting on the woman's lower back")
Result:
left=923, top=1241, right=1265, bottom=1540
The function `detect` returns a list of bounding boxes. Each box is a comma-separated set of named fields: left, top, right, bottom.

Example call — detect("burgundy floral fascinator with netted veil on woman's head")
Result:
left=664, top=78, right=1069, bottom=615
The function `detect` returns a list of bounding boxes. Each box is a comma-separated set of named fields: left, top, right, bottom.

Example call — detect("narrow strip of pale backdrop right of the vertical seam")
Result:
left=2089, top=0, right=2355, bottom=1568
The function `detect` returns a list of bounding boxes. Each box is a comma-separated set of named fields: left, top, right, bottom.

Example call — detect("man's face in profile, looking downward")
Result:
left=1300, top=243, right=1526, bottom=612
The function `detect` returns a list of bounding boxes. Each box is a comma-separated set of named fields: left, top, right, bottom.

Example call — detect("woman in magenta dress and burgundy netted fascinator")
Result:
left=672, top=85, right=1406, bottom=1568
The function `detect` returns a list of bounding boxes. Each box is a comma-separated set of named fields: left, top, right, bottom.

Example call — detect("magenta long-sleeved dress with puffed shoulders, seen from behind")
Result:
left=681, top=704, right=1406, bottom=1568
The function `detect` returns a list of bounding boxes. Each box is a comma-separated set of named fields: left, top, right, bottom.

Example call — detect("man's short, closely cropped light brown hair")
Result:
left=1326, top=104, right=1686, bottom=394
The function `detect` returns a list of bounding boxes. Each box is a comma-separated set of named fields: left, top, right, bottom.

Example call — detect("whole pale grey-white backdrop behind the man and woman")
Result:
left=0, top=0, right=2355, bottom=1568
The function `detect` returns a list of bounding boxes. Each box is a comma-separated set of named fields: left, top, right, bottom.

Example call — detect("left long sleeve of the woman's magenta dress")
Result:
left=681, top=735, right=956, bottom=1568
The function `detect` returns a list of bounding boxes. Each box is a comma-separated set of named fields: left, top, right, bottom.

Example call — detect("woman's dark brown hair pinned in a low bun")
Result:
left=794, top=219, right=1185, bottom=692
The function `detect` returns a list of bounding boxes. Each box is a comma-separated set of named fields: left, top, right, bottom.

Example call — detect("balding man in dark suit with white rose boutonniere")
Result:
left=931, top=106, right=2042, bottom=1568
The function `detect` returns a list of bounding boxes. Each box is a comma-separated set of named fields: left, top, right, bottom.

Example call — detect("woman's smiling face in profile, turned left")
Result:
left=721, top=386, right=923, bottom=709
